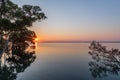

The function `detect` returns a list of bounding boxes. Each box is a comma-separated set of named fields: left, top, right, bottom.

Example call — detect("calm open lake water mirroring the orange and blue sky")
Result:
left=17, top=43, right=120, bottom=80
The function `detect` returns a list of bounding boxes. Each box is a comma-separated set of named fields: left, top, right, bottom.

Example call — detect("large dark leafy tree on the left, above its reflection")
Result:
left=0, top=0, right=46, bottom=47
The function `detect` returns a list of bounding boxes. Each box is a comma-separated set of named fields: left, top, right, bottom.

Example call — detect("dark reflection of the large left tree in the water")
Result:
left=0, top=43, right=36, bottom=80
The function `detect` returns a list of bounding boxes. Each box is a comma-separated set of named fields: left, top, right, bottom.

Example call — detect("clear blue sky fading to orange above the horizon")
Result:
left=12, top=0, right=120, bottom=41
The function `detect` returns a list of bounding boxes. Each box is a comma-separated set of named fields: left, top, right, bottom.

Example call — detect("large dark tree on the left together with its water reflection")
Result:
left=0, top=0, right=46, bottom=80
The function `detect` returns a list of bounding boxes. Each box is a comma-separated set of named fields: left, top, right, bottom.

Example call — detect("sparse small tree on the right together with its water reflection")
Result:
left=89, top=41, right=120, bottom=78
